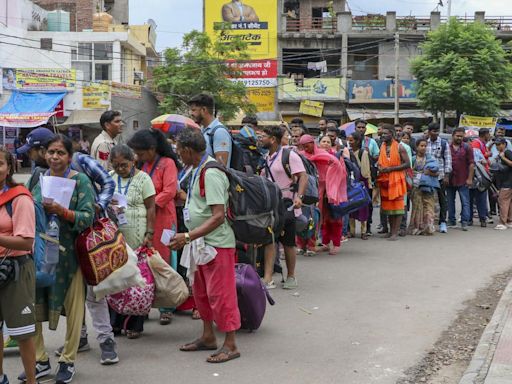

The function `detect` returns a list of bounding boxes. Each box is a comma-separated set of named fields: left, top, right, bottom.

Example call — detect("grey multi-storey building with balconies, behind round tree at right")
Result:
left=277, top=0, right=512, bottom=127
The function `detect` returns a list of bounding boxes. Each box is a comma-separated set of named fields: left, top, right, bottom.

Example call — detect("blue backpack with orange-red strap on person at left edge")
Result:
left=3, top=186, right=56, bottom=288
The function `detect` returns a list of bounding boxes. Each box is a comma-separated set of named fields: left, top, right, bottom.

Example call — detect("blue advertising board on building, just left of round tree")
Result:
left=348, top=80, right=416, bottom=102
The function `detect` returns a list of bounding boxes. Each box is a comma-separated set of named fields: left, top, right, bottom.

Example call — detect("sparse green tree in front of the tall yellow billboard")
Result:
left=154, top=31, right=256, bottom=120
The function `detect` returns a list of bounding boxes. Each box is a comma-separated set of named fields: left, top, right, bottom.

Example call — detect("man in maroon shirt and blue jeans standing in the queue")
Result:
left=446, top=127, right=475, bottom=231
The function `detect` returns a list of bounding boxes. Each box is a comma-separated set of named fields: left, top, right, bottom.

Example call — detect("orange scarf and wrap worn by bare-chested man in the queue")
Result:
left=377, top=140, right=407, bottom=216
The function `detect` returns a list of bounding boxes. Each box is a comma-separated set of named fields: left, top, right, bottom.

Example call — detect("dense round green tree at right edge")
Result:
left=412, top=19, right=512, bottom=118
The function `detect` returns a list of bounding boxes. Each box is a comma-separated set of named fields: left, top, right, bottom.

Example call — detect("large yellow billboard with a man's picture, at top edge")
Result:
left=204, top=0, right=278, bottom=59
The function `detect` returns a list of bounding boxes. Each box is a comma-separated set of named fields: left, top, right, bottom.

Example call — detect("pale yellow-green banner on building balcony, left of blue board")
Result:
left=278, top=78, right=342, bottom=100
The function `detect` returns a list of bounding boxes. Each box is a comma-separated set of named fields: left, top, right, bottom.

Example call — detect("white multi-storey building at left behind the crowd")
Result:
left=0, top=0, right=159, bottom=142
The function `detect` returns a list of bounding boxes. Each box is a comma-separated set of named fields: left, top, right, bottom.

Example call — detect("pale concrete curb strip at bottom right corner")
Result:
left=459, top=281, right=512, bottom=384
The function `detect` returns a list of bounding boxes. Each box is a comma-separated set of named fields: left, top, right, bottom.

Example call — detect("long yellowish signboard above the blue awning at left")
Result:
left=2, top=68, right=76, bottom=92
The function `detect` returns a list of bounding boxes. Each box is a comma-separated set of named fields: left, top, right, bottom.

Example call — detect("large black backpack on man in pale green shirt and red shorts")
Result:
left=199, top=161, right=285, bottom=244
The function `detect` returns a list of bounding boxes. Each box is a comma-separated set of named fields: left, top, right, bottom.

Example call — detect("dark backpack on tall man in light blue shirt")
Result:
left=208, top=125, right=262, bottom=174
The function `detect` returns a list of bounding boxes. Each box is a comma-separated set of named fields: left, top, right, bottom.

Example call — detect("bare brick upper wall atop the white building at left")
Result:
left=33, top=0, right=96, bottom=32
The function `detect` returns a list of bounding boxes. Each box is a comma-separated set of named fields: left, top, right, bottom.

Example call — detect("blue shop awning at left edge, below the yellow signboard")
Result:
left=0, top=91, right=66, bottom=128
